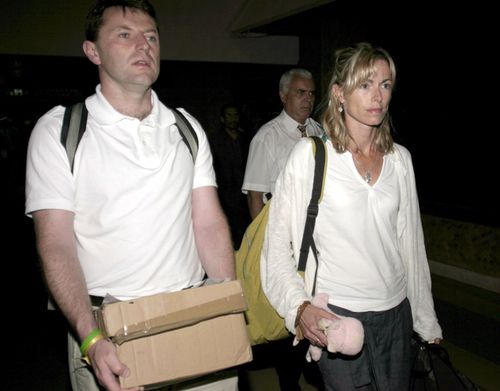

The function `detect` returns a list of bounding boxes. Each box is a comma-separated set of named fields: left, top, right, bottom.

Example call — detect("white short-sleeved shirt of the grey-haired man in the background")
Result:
left=241, top=110, right=324, bottom=194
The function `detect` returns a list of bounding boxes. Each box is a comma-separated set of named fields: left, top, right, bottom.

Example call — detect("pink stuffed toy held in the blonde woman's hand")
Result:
left=294, top=293, right=365, bottom=361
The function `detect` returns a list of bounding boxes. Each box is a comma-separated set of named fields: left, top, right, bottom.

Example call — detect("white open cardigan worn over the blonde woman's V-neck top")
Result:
left=261, top=139, right=442, bottom=341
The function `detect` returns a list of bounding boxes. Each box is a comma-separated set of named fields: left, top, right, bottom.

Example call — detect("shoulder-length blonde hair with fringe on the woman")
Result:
left=321, top=42, right=396, bottom=153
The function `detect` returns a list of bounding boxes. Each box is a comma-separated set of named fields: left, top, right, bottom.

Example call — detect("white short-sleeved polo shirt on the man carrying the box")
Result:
left=25, top=86, right=215, bottom=299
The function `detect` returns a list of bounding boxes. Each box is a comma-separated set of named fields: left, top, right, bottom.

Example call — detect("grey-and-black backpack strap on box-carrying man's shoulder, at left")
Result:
left=61, top=102, right=88, bottom=172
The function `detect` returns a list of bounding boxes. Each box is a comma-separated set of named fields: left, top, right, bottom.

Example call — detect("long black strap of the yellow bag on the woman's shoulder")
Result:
left=298, top=136, right=326, bottom=294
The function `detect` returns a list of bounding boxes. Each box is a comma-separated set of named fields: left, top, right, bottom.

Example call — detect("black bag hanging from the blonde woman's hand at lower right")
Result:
left=410, top=333, right=480, bottom=391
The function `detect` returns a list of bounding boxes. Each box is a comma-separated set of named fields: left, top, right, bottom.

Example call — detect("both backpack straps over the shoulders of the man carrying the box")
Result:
left=61, top=102, right=198, bottom=172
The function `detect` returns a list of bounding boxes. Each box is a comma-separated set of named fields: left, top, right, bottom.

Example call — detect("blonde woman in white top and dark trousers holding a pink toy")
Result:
left=261, top=43, right=442, bottom=391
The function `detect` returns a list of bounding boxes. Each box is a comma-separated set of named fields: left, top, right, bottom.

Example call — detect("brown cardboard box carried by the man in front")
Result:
left=96, top=281, right=252, bottom=388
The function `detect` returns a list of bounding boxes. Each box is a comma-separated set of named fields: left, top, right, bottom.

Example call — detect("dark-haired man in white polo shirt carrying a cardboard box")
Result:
left=25, top=0, right=237, bottom=391
